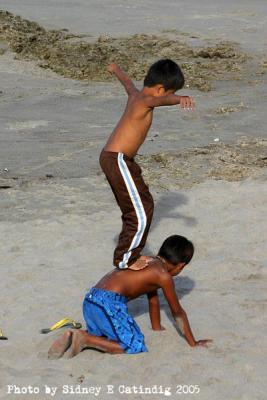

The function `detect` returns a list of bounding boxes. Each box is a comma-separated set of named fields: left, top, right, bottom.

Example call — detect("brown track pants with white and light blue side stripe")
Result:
left=99, top=150, right=154, bottom=269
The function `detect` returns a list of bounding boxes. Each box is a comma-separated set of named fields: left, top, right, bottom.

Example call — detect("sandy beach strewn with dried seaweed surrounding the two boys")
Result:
left=0, top=0, right=267, bottom=400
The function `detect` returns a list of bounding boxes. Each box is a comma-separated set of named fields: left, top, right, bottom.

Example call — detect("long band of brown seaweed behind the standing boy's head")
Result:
left=0, top=11, right=249, bottom=91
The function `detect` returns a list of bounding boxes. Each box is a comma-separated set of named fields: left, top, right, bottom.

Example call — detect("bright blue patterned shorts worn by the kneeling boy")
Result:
left=83, top=287, right=148, bottom=354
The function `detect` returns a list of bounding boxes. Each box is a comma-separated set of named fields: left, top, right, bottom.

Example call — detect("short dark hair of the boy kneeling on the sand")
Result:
left=158, top=235, right=194, bottom=265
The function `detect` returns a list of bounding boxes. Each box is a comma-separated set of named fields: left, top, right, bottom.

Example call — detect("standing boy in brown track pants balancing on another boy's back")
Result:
left=100, top=59, right=194, bottom=270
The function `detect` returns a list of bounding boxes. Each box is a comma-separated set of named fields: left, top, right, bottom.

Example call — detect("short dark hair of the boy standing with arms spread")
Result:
left=144, top=59, right=184, bottom=91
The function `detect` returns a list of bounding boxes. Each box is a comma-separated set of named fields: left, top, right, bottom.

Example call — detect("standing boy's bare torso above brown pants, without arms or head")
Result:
left=104, top=88, right=153, bottom=158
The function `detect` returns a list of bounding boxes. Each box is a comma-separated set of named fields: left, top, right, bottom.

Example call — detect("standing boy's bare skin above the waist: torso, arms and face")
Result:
left=104, top=64, right=193, bottom=158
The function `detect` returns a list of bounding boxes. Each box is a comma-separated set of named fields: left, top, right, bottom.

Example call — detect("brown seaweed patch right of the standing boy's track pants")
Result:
left=136, top=138, right=267, bottom=190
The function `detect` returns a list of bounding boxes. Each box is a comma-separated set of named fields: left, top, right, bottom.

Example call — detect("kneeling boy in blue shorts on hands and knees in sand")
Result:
left=48, top=235, right=210, bottom=358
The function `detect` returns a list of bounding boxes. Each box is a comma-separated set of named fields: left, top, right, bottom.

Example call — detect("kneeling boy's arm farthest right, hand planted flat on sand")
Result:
left=162, top=276, right=212, bottom=347
